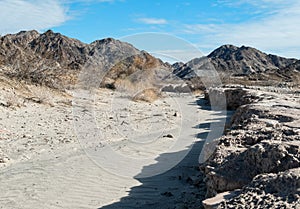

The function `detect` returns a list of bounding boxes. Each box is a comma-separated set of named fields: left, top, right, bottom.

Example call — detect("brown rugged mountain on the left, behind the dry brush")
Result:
left=0, top=30, right=168, bottom=88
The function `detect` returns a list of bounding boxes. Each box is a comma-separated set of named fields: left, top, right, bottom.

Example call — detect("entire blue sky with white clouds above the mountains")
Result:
left=0, top=0, right=300, bottom=61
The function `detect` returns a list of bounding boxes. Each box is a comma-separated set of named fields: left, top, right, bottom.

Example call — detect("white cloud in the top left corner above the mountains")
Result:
left=0, top=0, right=68, bottom=34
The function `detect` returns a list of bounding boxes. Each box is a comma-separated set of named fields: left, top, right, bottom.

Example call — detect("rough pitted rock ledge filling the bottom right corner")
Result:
left=216, top=168, right=300, bottom=209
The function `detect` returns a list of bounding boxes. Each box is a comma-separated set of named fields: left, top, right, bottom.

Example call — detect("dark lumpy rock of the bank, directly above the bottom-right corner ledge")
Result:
left=206, top=141, right=300, bottom=195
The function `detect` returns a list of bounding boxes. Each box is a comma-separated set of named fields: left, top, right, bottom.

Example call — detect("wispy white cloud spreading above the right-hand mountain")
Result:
left=183, top=0, right=300, bottom=58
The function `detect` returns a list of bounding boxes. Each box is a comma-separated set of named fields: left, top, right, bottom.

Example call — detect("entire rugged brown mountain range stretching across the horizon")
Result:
left=0, top=30, right=300, bottom=88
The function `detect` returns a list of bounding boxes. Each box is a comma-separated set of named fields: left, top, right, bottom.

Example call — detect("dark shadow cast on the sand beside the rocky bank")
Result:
left=99, top=99, right=229, bottom=209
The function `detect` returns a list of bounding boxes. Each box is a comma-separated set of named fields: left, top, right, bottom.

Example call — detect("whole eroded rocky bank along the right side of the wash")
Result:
left=201, top=88, right=300, bottom=208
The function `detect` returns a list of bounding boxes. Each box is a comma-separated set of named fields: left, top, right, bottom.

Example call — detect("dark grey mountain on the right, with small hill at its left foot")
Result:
left=173, top=45, right=300, bottom=86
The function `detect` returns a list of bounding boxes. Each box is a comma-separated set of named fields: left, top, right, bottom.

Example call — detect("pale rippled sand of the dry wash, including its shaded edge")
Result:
left=0, top=87, right=225, bottom=209
